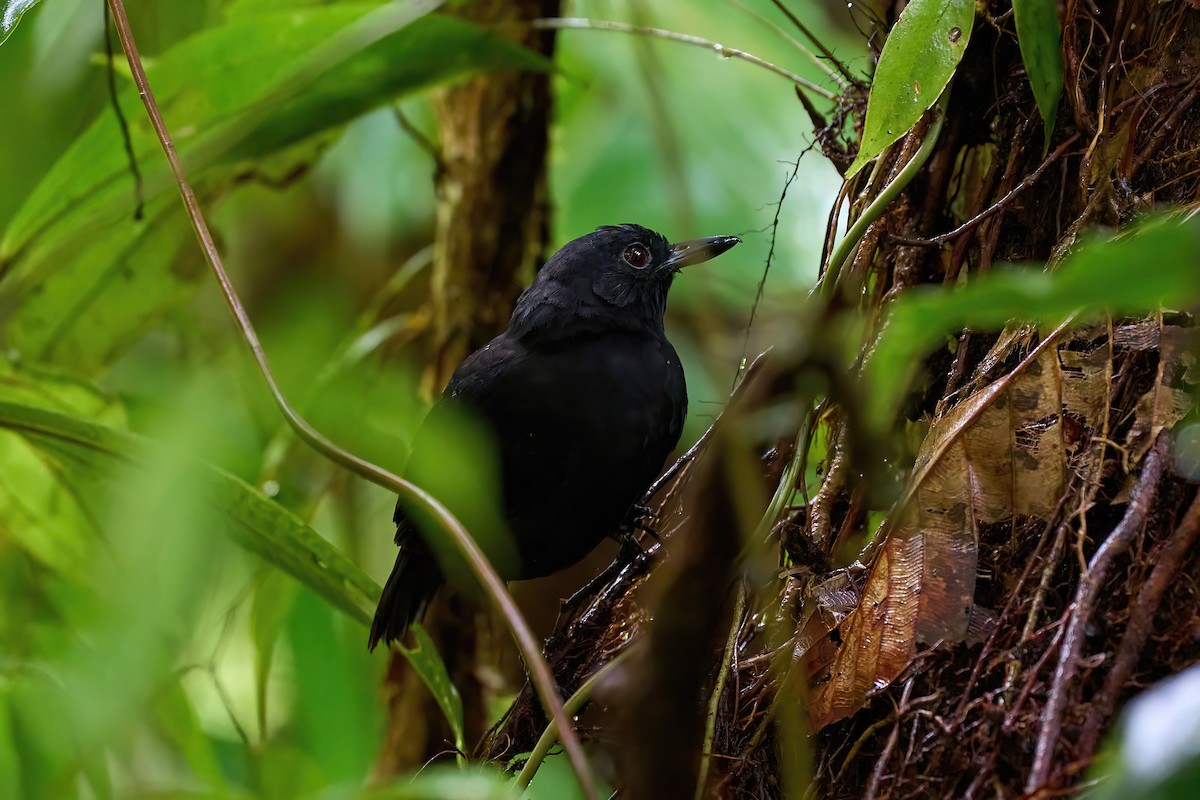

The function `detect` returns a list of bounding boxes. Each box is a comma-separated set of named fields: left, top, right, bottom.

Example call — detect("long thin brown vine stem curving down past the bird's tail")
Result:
left=100, top=0, right=598, bottom=800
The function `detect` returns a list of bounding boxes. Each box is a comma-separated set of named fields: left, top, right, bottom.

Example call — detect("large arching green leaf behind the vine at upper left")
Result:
left=0, top=2, right=547, bottom=372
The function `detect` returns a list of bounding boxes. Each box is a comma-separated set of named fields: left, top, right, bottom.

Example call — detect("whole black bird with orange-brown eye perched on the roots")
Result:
left=368, top=224, right=740, bottom=649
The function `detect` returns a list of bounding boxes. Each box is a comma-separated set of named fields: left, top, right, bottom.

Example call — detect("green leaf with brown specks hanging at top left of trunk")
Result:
left=846, top=0, right=974, bottom=178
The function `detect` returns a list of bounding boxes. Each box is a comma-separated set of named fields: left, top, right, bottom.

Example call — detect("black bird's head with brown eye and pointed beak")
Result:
left=509, top=224, right=742, bottom=336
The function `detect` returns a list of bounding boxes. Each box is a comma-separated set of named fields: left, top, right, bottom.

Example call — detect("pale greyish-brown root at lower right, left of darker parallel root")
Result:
left=1025, top=434, right=1170, bottom=794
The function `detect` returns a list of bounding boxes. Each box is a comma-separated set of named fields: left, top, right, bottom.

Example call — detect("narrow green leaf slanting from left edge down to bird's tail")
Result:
left=0, top=402, right=379, bottom=624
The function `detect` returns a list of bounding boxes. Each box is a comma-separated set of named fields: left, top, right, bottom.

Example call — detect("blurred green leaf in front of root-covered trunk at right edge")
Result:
left=865, top=217, right=1200, bottom=429
